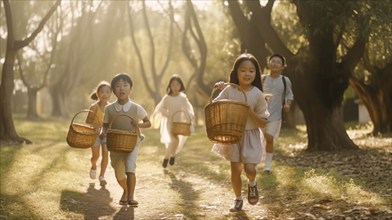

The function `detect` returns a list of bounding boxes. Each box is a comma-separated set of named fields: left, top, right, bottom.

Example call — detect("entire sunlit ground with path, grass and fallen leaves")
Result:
left=0, top=121, right=392, bottom=220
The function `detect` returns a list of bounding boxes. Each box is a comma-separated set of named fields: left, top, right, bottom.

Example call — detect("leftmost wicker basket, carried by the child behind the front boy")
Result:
left=67, top=109, right=99, bottom=149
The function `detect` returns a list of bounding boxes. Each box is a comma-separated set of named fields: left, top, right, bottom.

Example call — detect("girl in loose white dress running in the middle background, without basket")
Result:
left=153, top=75, right=194, bottom=168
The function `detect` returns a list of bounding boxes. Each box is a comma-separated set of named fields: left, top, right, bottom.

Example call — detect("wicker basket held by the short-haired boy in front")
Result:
left=106, top=114, right=140, bottom=152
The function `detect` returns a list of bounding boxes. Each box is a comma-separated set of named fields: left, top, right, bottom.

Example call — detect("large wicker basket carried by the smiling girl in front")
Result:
left=204, top=83, right=249, bottom=144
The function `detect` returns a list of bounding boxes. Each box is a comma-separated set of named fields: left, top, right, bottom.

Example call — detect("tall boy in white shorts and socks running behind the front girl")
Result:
left=263, top=54, right=294, bottom=174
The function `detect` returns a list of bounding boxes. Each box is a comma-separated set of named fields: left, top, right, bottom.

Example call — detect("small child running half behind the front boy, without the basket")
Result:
left=86, top=81, right=112, bottom=186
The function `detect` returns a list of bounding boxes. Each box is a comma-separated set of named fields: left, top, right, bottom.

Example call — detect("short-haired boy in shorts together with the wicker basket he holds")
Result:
left=101, top=73, right=151, bottom=207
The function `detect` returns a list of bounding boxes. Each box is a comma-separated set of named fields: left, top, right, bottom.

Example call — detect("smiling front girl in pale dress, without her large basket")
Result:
left=212, top=53, right=269, bottom=212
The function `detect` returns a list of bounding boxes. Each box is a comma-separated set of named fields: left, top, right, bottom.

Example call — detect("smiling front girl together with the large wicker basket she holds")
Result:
left=205, top=53, right=269, bottom=212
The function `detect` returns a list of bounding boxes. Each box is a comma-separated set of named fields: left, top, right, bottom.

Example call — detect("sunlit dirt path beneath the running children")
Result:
left=80, top=156, right=266, bottom=219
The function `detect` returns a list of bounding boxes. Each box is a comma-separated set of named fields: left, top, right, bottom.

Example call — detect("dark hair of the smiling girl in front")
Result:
left=230, top=53, right=263, bottom=91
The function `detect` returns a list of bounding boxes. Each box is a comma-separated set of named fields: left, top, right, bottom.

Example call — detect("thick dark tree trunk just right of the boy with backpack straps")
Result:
left=285, top=59, right=358, bottom=151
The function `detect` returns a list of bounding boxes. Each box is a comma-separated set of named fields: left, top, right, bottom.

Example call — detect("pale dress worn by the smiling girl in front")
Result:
left=212, top=86, right=269, bottom=164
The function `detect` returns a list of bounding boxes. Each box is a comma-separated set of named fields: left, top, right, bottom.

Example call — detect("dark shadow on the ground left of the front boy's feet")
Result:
left=60, top=183, right=116, bottom=220
